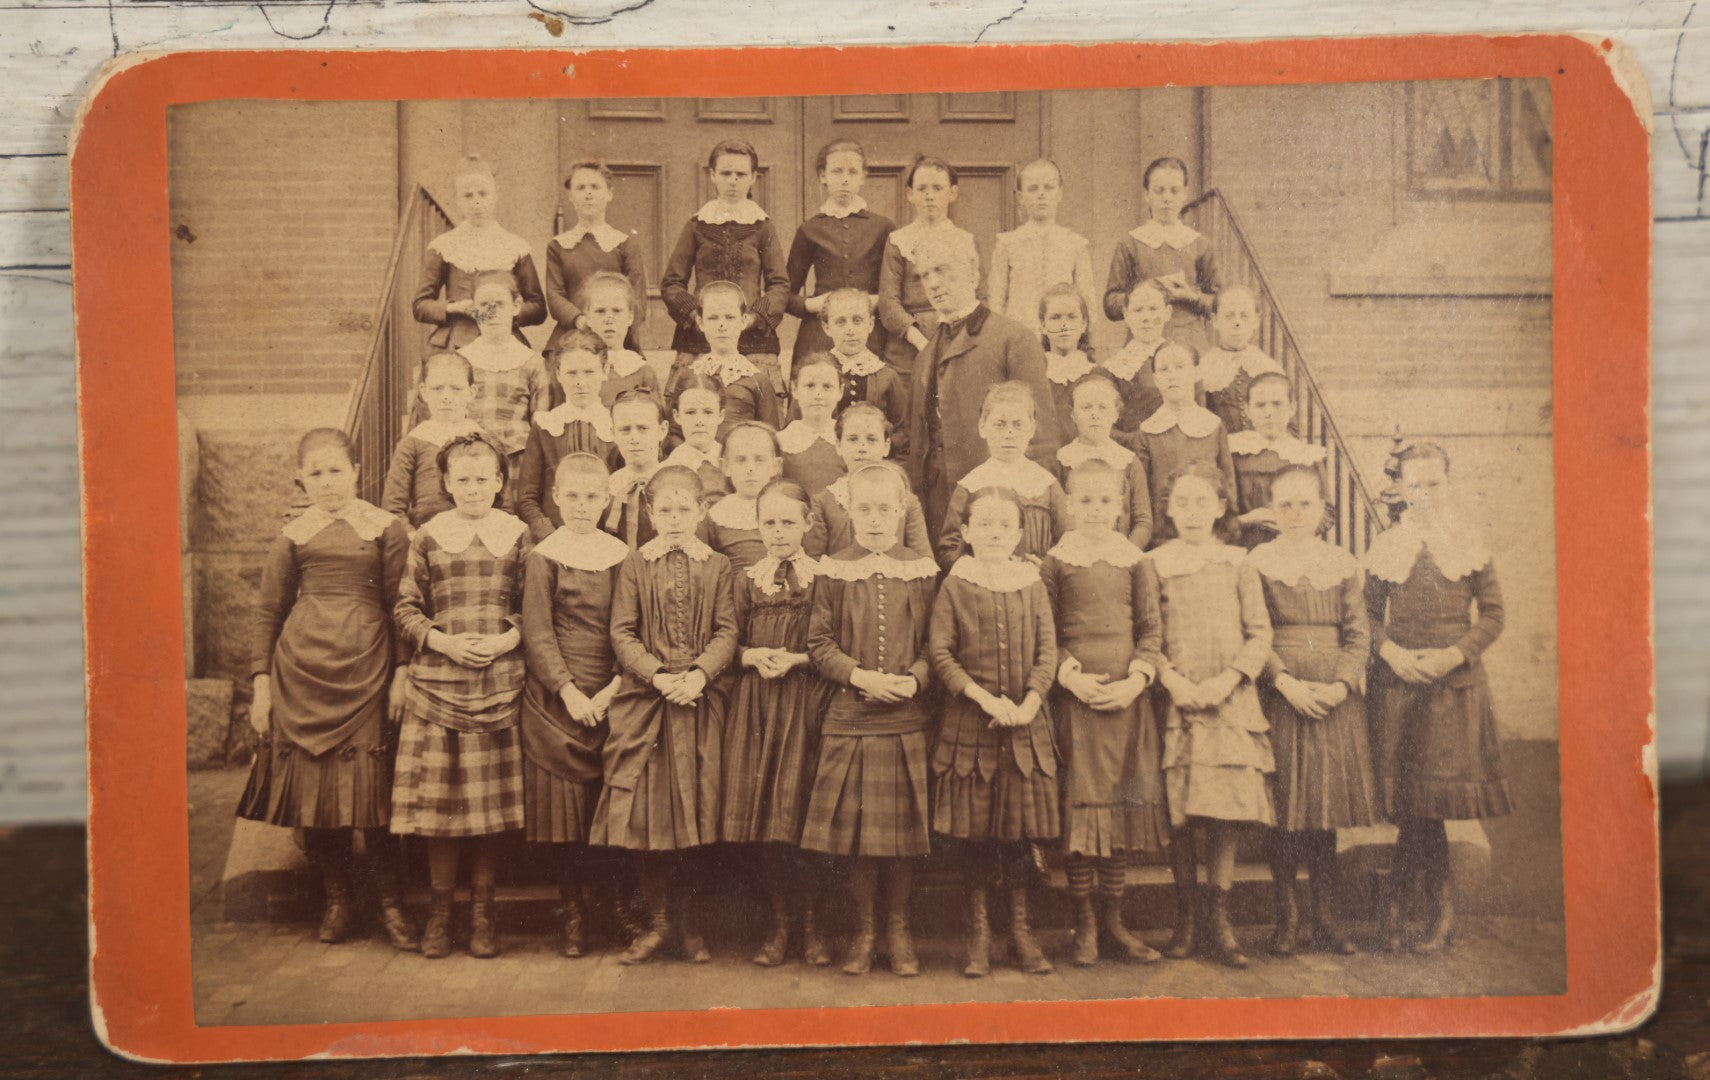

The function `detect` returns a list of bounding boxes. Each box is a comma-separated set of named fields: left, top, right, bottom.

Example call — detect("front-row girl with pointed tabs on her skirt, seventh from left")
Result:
left=927, top=487, right=1058, bottom=977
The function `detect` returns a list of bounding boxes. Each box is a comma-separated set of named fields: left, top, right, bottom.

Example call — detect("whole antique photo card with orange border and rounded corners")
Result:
left=72, top=36, right=1660, bottom=1061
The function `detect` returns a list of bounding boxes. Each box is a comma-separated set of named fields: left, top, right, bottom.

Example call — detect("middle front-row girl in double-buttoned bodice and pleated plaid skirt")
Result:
left=802, top=465, right=939, bottom=976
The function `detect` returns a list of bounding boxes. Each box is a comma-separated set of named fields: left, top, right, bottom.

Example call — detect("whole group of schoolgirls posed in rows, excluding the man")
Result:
left=239, top=142, right=1508, bottom=976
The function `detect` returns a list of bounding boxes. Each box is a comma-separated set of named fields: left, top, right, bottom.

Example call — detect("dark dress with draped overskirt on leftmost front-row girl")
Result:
left=238, top=499, right=409, bottom=829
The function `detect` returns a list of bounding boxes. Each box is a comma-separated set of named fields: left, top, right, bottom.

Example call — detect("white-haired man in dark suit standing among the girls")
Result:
left=908, top=236, right=1062, bottom=540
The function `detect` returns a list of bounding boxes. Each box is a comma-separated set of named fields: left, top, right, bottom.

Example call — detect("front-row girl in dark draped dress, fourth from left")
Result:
left=590, top=465, right=737, bottom=964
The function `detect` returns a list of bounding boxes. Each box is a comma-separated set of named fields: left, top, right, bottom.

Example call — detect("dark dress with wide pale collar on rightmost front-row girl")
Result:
left=1366, top=518, right=1512, bottom=819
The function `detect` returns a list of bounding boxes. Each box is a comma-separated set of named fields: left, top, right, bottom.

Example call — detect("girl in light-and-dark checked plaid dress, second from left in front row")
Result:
left=392, top=434, right=528, bottom=957
